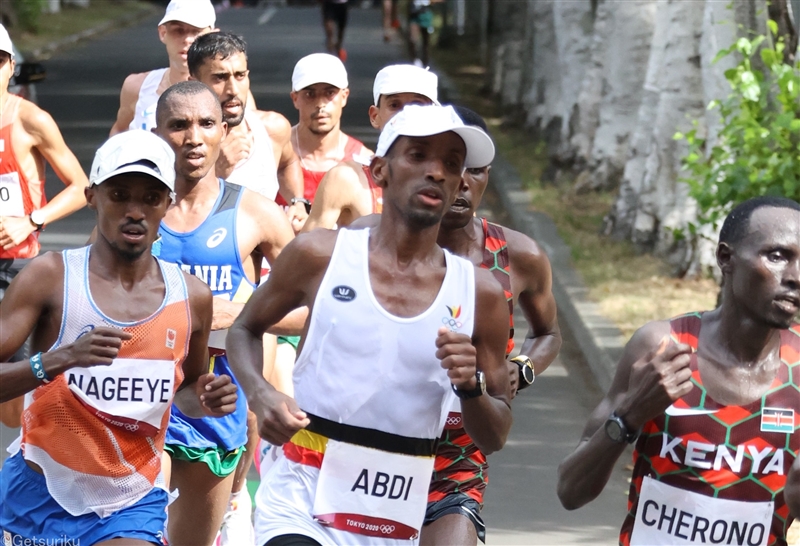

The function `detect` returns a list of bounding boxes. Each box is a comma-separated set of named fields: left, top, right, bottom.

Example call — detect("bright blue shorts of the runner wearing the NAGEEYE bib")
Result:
left=0, top=452, right=167, bottom=546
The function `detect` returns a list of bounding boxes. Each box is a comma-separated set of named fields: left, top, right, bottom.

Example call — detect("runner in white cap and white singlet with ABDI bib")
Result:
left=227, top=106, right=511, bottom=546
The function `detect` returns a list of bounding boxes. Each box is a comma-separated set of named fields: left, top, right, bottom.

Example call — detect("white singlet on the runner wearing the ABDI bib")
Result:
left=294, top=229, right=475, bottom=439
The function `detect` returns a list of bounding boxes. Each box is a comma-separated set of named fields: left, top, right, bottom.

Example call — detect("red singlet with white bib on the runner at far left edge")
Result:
left=0, top=94, right=47, bottom=259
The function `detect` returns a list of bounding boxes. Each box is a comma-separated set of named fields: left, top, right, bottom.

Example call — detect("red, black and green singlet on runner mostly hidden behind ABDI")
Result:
left=428, top=218, right=514, bottom=504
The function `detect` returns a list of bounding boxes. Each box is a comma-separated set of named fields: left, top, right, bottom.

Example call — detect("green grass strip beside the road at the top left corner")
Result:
left=9, top=0, right=157, bottom=54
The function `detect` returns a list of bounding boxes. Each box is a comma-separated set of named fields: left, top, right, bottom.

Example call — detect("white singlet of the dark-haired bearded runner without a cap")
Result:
left=228, top=110, right=278, bottom=200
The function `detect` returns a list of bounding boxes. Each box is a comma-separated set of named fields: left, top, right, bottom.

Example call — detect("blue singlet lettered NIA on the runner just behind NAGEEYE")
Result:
left=154, top=179, right=256, bottom=451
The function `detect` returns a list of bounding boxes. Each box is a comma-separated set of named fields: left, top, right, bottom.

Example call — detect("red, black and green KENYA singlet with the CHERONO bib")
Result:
left=619, top=313, right=800, bottom=546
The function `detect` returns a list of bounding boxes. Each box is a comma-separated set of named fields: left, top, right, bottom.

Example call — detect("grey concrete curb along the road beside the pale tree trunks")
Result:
left=431, top=61, right=625, bottom=391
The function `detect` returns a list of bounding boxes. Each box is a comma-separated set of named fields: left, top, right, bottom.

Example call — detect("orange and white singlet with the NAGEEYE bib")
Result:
left=22, top=247, right=192, bottom=517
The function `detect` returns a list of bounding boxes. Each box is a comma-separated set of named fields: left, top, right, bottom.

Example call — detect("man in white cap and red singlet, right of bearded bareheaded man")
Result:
left=276, top=53, right=372, bottom=210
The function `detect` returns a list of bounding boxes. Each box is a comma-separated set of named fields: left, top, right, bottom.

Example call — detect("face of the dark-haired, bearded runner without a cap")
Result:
left=192, top=53, right=250, bottom=127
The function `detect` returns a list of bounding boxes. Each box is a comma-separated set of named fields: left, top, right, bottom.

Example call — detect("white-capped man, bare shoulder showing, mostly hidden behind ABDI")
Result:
left=303, top=64, right=438, bottom=232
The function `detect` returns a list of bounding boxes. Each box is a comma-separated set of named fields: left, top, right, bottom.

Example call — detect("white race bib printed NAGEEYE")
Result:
left=66, top=358, right=175, bottom=437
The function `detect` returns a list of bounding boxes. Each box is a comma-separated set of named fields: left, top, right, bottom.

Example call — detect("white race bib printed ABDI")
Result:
left=312, top=440, right=433, bottom=540
